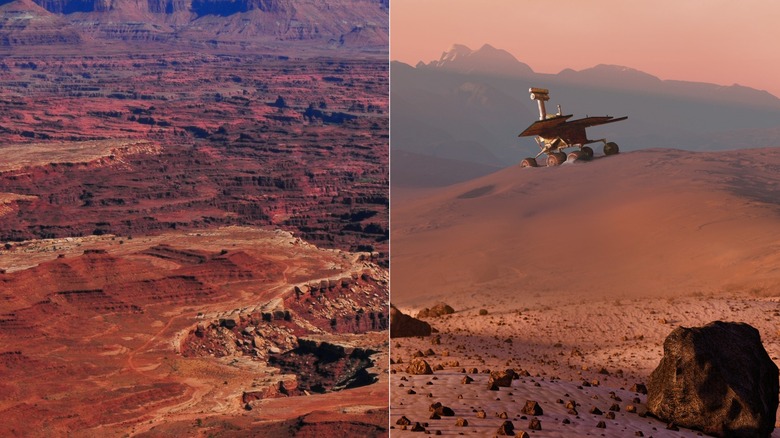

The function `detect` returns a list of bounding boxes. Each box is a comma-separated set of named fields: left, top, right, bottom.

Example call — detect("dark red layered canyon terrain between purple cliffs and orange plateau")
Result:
left=0, top=53, right=388, bottom=262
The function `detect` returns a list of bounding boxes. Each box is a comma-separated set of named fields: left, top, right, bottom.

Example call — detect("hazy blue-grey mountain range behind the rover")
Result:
left=391, top=45, right=780, bottom=186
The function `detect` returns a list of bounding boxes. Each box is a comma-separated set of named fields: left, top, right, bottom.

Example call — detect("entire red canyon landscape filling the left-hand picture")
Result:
left=0, top=1, right=389, bottom=436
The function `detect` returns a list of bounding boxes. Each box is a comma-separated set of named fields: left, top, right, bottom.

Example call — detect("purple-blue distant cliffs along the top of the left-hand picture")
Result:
left=0, top=0, right=388, bottom=52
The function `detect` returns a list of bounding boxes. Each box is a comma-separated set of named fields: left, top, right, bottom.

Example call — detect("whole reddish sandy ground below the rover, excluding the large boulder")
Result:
left=390, top=149, right=780, bottom=437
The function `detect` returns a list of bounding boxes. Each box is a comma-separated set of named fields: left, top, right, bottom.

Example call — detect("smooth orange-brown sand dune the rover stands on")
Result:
left=392, top=149, right=780, bottom=306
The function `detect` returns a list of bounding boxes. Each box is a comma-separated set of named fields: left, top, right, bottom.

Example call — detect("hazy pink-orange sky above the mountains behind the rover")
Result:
left=390, top=0, right=780, bottom=97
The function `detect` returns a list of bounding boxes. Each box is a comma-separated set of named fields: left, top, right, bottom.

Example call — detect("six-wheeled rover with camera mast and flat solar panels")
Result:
left=519, top=88, right=628, bottom=167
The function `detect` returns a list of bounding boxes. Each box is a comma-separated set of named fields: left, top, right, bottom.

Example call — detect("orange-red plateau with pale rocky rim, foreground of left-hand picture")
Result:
left=0, top=227, right=387, bottom=435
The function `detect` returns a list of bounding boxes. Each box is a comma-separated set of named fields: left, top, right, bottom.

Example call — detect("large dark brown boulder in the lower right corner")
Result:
left=647, top=321, right=778, bottom=437
